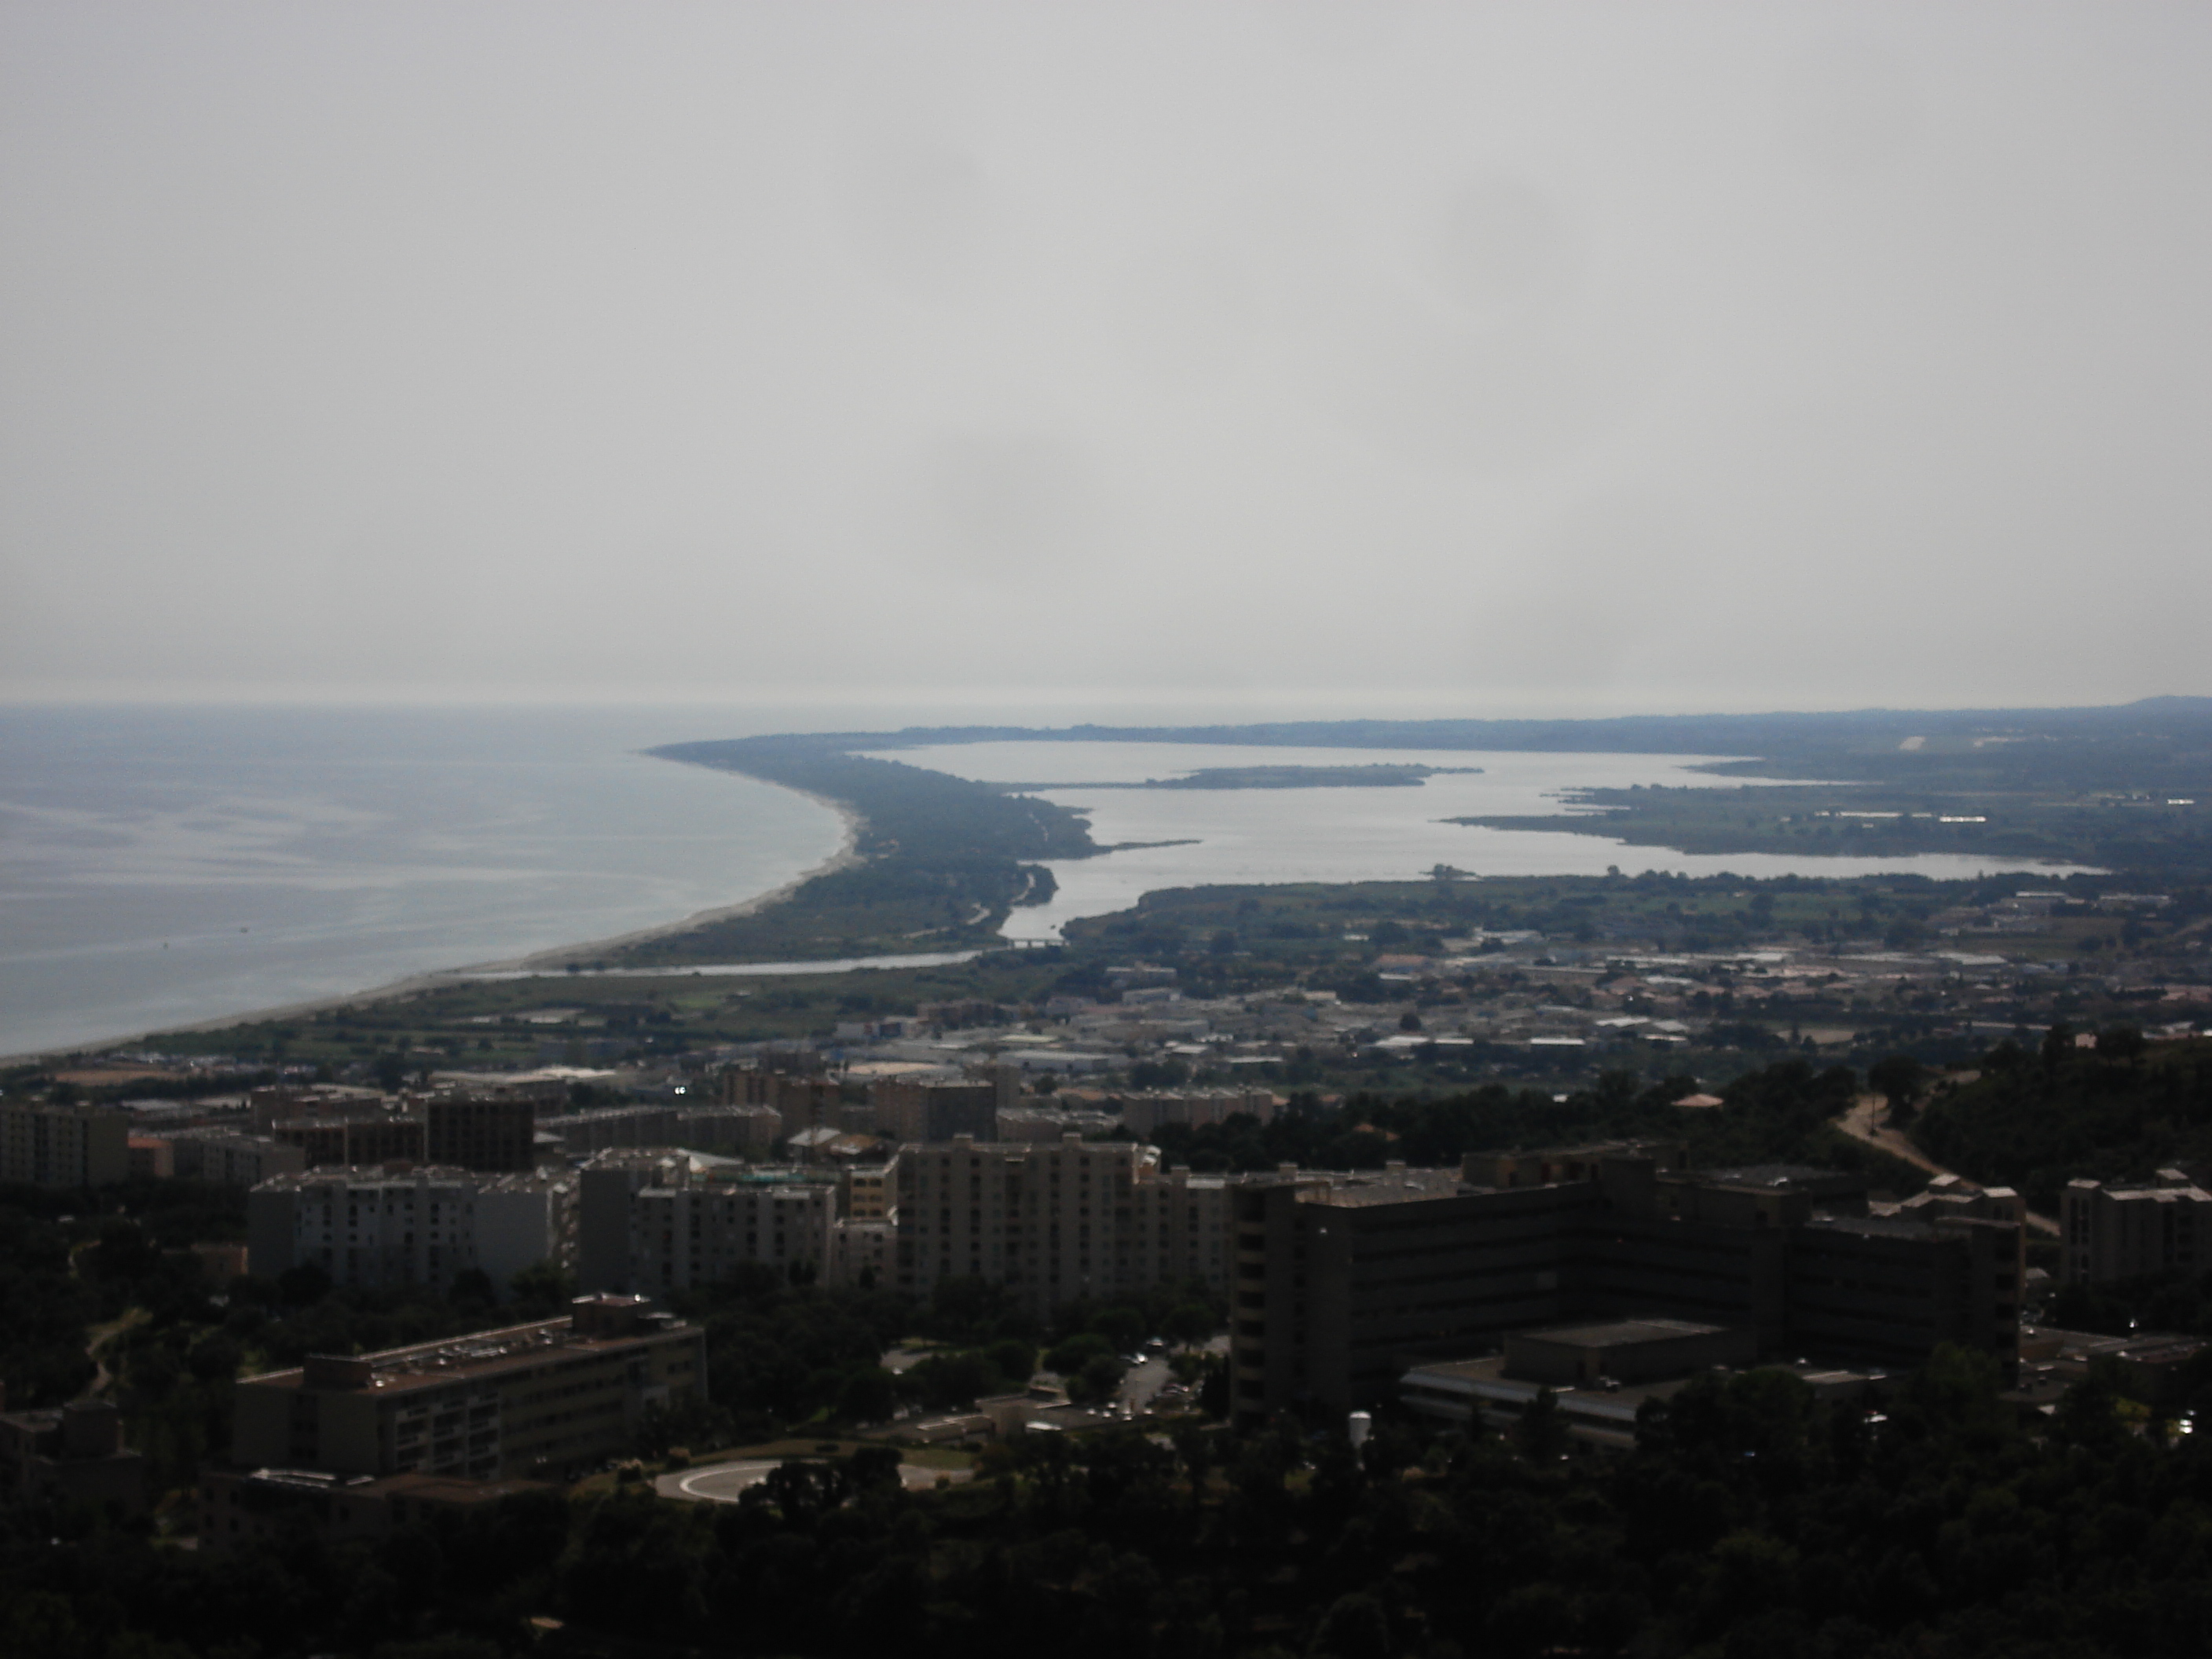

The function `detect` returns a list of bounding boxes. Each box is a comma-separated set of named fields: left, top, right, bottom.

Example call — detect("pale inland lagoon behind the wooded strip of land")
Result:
left=862, top=743, right=2088, bottom=940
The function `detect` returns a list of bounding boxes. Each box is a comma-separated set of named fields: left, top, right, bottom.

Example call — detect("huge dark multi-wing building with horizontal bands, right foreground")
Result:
left=1232, top=1144, right=2022, bottom=1418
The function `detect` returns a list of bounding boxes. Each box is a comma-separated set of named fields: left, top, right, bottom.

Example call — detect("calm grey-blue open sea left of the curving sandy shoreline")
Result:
left=0, top=708, right=843, bottom=1055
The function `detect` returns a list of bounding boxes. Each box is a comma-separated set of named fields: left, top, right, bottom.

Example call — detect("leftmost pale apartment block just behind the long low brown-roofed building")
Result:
left=246, top=1168, right=575, bottom=1287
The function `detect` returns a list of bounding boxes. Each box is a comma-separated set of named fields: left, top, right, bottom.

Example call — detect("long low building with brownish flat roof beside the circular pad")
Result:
left=233, top=1296, right=705, bottom=1480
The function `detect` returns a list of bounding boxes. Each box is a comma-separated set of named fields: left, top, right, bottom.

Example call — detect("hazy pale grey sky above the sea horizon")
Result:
left=0, top=0, right=2212, bottom=716
